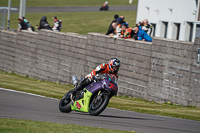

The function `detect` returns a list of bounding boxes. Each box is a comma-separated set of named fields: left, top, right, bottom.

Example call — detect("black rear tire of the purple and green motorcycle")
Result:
left=59, top=92, right=72, bottom=113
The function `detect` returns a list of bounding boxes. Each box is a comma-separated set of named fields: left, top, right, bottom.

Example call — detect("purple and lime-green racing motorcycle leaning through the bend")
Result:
left=59, top=74, right=118, bottom=116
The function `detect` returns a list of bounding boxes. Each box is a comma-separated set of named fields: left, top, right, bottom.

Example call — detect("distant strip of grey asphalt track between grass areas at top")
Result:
left=12, top=6, right=137, bottom=13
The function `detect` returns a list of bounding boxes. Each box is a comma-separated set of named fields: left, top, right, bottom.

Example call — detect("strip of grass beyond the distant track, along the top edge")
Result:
left=0, top=0, right=138, bottom=7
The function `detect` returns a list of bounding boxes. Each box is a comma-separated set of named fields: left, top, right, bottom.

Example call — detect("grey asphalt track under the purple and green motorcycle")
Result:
left=0, top=88, right=200, bottom=133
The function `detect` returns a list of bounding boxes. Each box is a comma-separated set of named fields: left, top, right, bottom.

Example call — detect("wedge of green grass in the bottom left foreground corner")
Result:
left=0, top=118, right=134, bottom=133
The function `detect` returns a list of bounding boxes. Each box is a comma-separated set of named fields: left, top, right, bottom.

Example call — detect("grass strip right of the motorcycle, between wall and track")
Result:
left=109, top=96, right=200, bottom=121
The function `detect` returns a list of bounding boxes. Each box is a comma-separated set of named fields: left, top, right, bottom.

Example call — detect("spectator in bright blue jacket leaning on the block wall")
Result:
left=134, top=25, right=152, bottom=42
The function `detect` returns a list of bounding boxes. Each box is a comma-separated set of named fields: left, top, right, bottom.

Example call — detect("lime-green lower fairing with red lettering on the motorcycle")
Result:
left=71, top=88, right=92, bottom=112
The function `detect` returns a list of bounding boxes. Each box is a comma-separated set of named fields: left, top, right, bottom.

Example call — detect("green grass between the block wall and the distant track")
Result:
left=7, top=11, right=136, bottom=35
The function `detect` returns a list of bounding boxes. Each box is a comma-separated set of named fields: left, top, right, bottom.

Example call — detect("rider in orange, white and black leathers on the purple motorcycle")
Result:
left=70, top=58, right=120, bottom=94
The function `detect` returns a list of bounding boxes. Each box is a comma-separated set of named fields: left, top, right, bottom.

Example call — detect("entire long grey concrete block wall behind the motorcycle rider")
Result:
left=0, top=31, right=200, bottom=107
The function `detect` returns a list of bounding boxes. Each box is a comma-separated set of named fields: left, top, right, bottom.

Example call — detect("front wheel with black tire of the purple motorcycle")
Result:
left=89, top=94, right=110, bottom=116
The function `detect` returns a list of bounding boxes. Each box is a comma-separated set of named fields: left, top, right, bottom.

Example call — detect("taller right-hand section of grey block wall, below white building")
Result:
left=148, top=38, right=200, bottom=106
